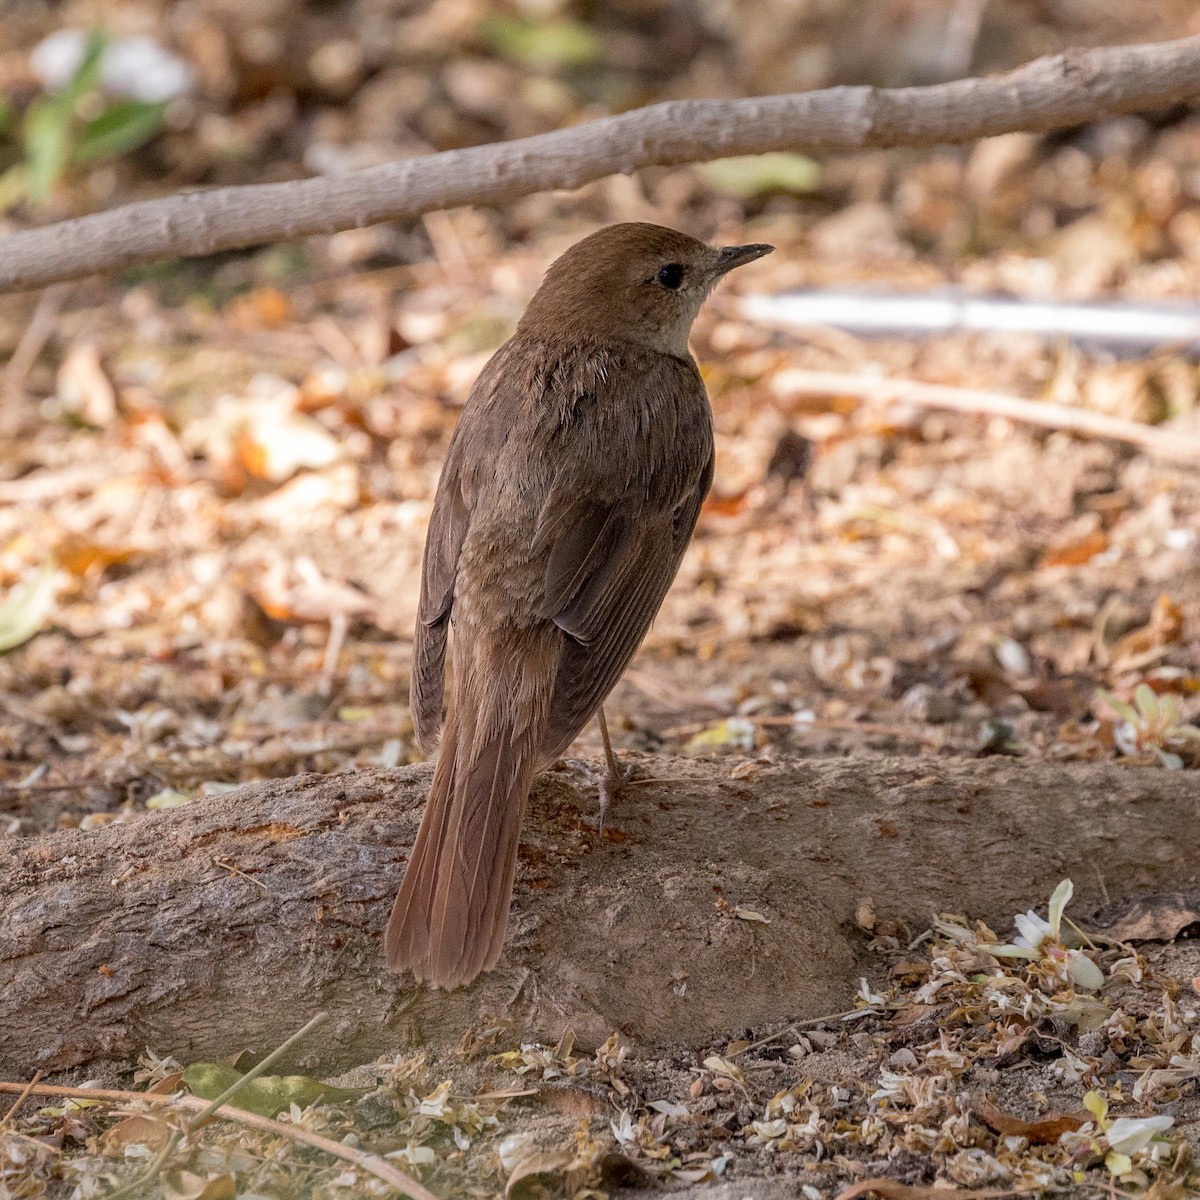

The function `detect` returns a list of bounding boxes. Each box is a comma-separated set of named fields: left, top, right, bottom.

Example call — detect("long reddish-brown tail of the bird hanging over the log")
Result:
left=384, top=657, right=548, bottom=989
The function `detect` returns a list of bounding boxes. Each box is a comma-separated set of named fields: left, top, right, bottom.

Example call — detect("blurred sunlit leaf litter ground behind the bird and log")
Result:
left=0, top=0, right=1200, bottom=836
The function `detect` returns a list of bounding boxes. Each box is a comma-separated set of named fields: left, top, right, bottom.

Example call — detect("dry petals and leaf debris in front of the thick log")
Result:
left=0, top=882, right=1200, bottom=1200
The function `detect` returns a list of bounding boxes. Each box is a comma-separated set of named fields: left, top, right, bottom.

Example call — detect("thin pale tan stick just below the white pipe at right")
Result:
left=775, top=370, right=1200, bottom=466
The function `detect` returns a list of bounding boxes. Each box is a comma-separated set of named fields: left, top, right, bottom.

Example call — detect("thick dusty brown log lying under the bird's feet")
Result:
left=0, top=756, right=1200, bottom=1078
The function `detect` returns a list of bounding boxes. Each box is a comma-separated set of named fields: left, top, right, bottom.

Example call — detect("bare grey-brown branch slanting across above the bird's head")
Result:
left=0, top=36, right=1200, bottom=292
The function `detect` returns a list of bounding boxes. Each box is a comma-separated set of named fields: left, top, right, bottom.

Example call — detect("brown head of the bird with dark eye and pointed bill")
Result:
left=520, top=222, right=774, bottom=356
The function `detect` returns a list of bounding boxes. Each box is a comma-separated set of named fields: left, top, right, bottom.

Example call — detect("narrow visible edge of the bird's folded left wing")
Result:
left=409, top=438, right=470, bottom=751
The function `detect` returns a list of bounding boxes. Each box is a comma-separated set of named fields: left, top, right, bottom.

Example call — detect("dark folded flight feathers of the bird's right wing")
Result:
left=542, top=451, right=713, bottom=760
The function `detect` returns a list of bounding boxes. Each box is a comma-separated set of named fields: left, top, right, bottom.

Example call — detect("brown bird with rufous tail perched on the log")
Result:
left=385, top=224, right=773, bottom=988
